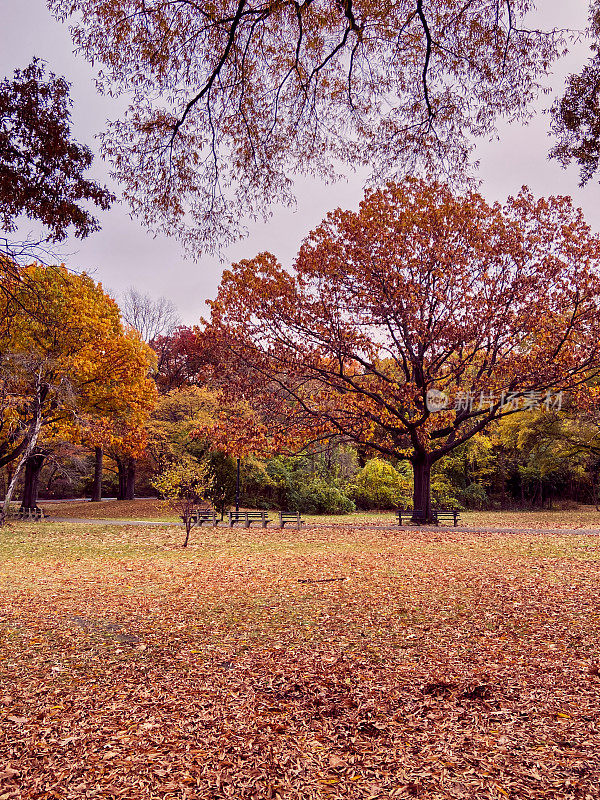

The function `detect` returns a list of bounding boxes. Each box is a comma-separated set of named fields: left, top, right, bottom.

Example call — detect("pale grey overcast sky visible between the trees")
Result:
left=0, top=0, right=600, bottom=324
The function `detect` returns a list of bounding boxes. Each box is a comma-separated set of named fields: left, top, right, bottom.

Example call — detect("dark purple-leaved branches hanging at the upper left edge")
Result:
left=0, top=59, right=114, bottom=267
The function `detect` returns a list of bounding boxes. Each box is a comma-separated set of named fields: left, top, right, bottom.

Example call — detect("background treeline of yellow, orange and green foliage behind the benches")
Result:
left=0, top=274, right=600, bottom=514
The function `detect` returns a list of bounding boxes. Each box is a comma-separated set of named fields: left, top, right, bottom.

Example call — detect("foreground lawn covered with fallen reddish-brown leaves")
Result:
left=0, top=524, right=600, bottom=800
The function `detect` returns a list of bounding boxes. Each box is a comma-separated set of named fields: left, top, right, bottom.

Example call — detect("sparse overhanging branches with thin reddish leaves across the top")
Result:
left=48, top=0, right=561, bottom=254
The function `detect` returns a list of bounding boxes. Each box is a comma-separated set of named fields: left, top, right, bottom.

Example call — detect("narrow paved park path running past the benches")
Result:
left=43, top=517, right=600, bottom=536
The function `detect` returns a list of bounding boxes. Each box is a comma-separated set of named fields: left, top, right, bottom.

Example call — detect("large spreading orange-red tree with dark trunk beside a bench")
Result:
left=205, top=180, right=600, bottom=519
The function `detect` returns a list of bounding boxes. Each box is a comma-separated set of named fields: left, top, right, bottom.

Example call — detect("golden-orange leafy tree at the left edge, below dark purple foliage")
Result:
left=0, top=265, right=156, bottom=511
